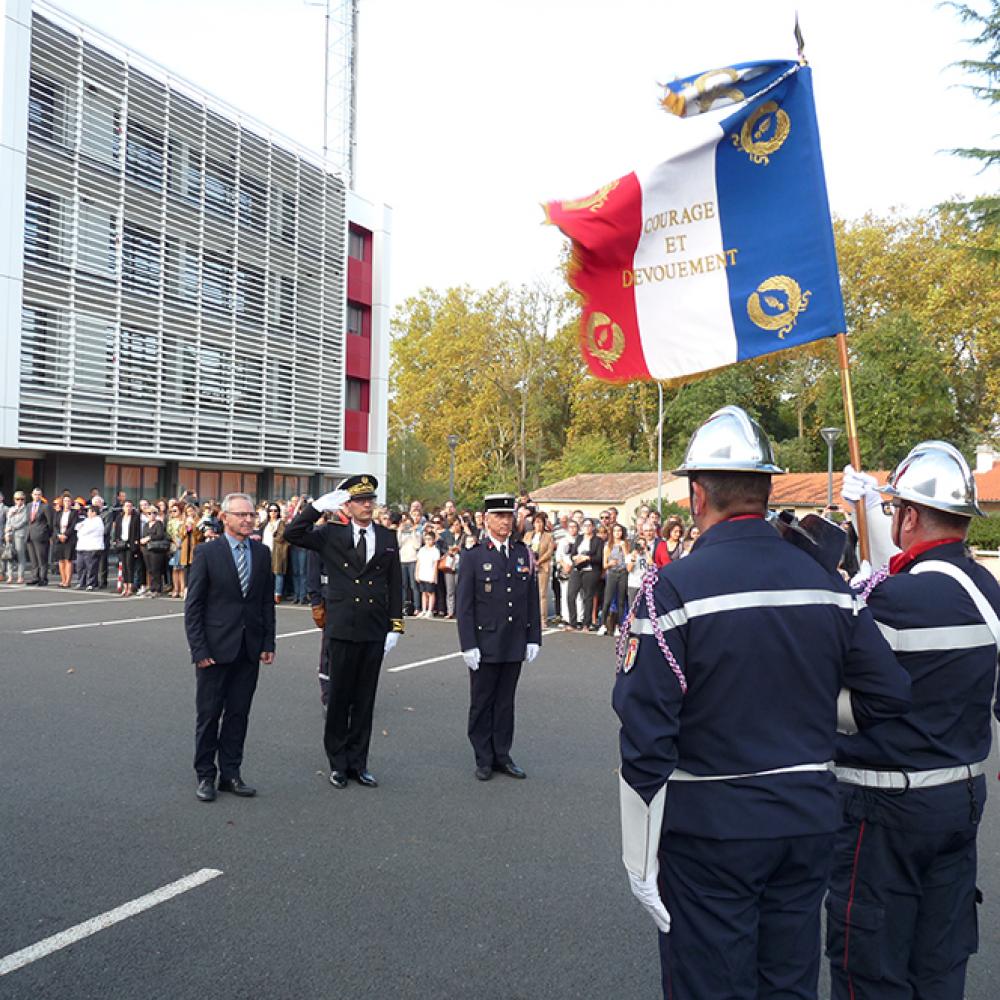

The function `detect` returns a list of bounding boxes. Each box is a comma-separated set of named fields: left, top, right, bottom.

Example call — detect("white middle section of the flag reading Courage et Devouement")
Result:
left=634, top=118, right=737, bottom=379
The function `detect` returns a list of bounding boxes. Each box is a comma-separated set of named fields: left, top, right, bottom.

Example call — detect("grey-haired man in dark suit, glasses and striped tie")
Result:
left=184, top=493, right=274, bottom=802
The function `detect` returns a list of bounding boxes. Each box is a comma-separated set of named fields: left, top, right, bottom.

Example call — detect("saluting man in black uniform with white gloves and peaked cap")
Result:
left=285, top=475, right=403, bottom=788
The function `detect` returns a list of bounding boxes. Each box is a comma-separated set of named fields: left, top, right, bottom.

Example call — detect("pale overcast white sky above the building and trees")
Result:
left=41, top=0, right=997, bottom=303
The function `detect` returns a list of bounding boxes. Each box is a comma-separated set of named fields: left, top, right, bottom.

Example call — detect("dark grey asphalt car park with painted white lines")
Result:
left=0, top=585, right=1000, bottom=1000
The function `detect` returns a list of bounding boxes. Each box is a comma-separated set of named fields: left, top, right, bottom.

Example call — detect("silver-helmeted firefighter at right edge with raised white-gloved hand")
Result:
left=827, top=441, right=1000, bottom=1000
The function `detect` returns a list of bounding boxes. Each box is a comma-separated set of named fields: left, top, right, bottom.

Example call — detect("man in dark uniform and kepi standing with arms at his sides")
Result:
left=455, top=493, right=542, bottom=781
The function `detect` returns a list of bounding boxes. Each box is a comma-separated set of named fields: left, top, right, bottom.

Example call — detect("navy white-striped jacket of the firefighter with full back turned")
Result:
left=614, top=518, right=909, bottom=840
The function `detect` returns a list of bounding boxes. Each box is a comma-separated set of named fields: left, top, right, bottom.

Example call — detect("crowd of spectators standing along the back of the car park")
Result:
left=0, top=489, right=698, bottom=634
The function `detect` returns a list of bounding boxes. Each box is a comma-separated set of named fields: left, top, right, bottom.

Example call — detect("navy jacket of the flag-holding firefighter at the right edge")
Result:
left=836, top=541, right=1000, bottom=830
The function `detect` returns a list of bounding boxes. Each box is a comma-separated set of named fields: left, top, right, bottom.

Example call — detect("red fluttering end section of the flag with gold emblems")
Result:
left=545, top=174, right=650, bottom=382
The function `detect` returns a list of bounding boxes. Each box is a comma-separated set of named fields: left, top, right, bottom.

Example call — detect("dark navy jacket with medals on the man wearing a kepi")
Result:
left=455, top=537, right=542, bottom=663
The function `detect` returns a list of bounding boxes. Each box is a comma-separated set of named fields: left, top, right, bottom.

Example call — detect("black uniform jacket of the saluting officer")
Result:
left=285, top=504, right=403, bottom=642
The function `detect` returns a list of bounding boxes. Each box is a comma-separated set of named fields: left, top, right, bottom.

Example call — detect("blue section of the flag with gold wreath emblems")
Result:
left=716, top=66, right=845, bottom=361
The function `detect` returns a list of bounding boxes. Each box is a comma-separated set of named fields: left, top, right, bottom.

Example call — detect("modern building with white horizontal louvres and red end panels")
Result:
left=0, top=0, right=391, bottom=498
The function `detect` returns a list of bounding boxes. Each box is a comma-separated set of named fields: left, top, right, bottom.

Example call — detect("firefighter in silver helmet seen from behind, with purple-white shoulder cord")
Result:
left=614, top=406, right=910, bottom=1000
